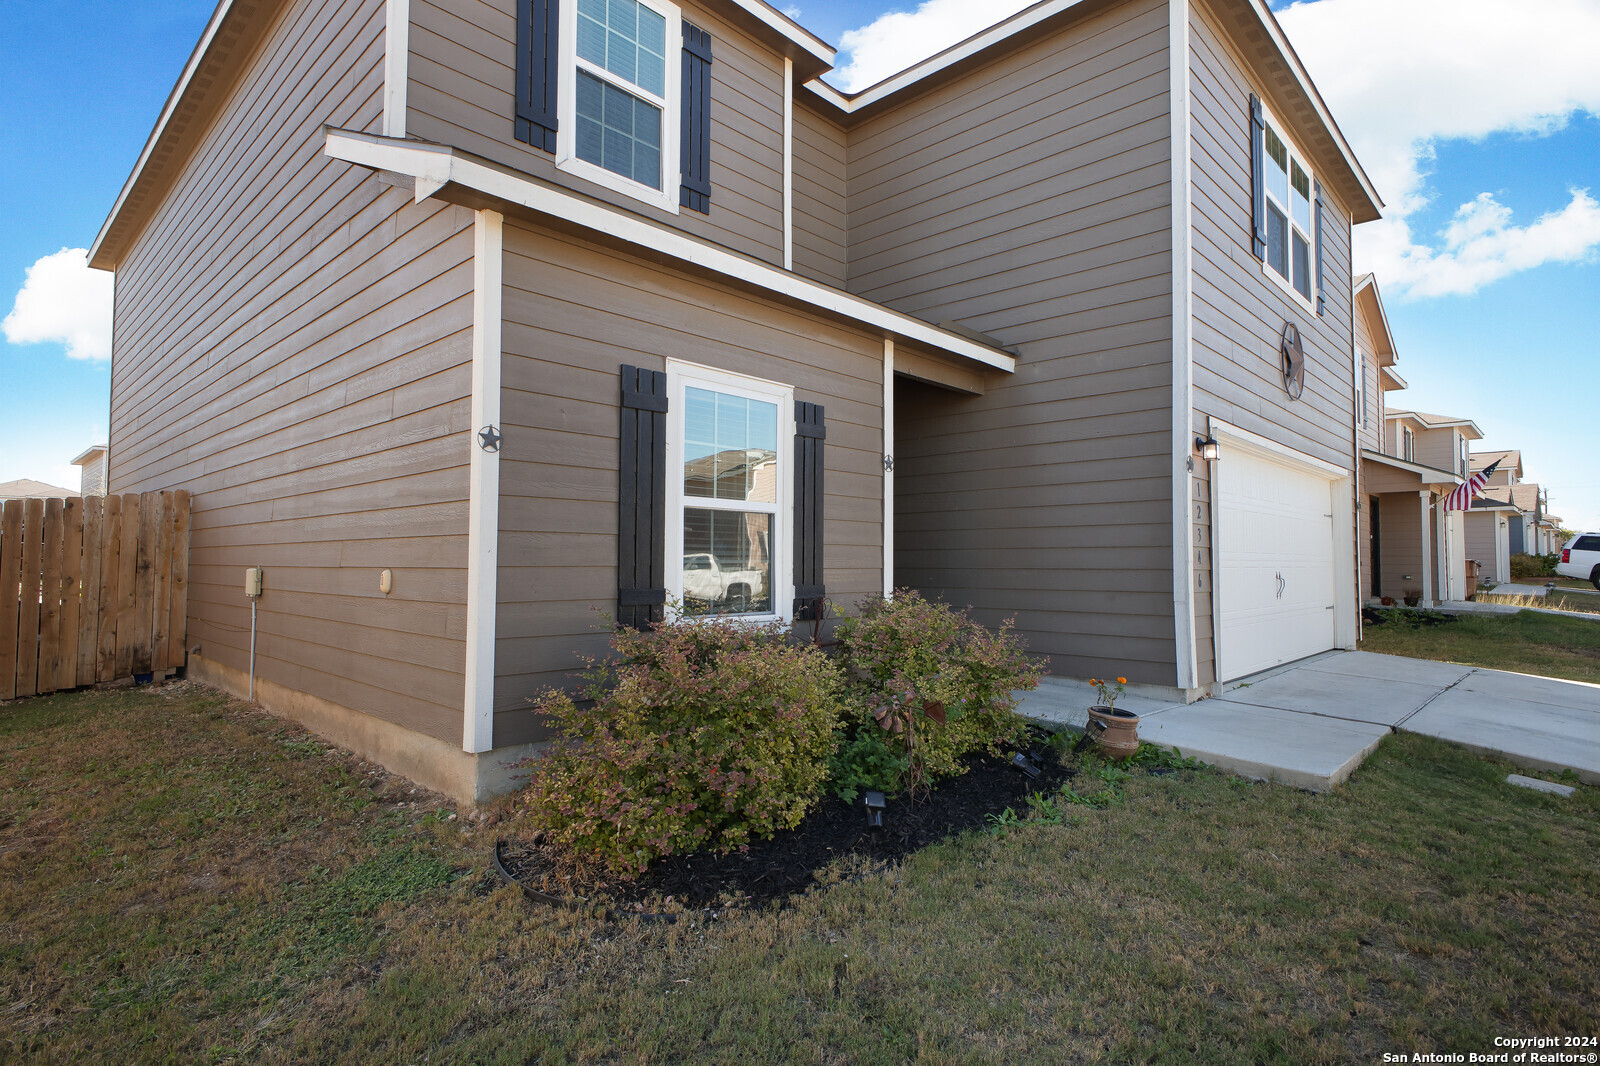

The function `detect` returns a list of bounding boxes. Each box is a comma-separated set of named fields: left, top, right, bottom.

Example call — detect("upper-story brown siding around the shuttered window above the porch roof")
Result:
left=406, top=0, right=784, bottom=264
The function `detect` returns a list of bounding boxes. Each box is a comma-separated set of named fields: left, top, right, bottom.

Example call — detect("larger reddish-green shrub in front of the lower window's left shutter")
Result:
left=525, top=621, right=842, bottom=877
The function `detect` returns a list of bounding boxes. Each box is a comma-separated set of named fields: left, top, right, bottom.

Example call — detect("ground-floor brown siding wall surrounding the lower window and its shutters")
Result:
left=494, top=222, right=883, bottom=744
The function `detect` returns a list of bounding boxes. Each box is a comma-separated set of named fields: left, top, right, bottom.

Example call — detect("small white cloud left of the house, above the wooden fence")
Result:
left=0, top=248, right=112, bottom=359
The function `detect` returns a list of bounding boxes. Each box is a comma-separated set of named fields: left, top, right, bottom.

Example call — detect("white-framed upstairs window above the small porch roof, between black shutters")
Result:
left=555, top=0, right=683, bottom=214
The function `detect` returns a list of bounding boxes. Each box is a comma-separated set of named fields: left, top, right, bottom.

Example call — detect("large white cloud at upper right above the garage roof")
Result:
left=1278, top=0, right=1600, bottom=296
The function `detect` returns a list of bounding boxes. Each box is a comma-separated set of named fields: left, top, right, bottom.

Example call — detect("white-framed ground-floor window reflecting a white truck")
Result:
left=666, top=360, right=795, bottom=621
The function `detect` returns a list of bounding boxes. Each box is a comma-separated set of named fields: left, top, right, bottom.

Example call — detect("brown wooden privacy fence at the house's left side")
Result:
left=0, top=490, right=189, bottom=699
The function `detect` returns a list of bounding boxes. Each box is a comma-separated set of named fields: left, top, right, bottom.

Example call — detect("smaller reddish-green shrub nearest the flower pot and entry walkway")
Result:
left=838, top=589, right=1043, bottom=791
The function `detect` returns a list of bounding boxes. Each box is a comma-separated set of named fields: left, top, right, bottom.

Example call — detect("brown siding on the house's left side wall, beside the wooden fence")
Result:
left=110, top=0, right=472, bottom=743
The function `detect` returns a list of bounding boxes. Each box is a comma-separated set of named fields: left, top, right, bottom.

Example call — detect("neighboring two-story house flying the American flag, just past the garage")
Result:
left=1355, top=284, right=1482, bottom=603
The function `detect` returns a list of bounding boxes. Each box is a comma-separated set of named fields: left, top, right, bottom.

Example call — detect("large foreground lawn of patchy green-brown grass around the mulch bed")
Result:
left=0, top=675, right=1600, bottom=1064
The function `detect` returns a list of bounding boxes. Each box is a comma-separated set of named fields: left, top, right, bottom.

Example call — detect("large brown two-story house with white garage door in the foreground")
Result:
left=91, top=0, right=1379, bottom=797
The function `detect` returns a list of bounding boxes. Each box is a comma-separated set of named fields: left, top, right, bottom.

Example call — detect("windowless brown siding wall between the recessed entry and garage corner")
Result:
left=848, top=0, right=1176, bottom=685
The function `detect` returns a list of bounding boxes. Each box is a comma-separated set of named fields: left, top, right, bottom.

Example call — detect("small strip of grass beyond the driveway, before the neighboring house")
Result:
left=1360, top=611, right=1600, bottom=683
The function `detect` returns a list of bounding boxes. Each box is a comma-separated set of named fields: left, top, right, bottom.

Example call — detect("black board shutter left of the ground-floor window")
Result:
left=616, top=367, right=667, bottom=629
